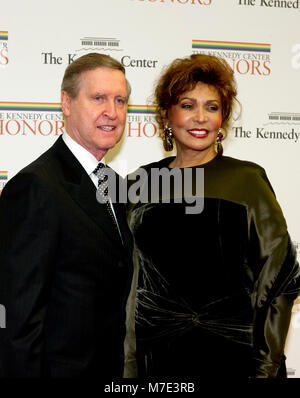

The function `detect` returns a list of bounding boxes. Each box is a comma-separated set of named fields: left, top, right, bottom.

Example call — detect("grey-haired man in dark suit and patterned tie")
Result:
left=0, top=53, right=132, bottom=378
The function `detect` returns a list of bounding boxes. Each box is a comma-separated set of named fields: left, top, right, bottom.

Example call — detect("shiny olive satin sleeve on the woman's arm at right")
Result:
left=248, top=169, right=300, bottom=378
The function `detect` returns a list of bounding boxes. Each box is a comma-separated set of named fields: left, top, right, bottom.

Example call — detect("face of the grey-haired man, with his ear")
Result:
left=61, top=67, right=127, bottom=161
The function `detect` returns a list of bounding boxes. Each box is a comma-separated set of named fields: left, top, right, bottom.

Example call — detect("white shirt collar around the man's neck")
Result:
left=62, top=132, right=105, bottom=175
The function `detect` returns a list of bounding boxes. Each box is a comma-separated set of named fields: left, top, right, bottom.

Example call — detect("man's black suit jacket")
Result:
left=0, top=137, right=132, bottom=377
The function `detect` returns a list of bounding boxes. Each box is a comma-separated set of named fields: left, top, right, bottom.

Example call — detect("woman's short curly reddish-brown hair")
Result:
left=154, top=54, right=238, bottom=131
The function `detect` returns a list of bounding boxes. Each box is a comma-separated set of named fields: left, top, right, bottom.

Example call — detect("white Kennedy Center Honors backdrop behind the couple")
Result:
left=0, top=0, right=300, bottom=378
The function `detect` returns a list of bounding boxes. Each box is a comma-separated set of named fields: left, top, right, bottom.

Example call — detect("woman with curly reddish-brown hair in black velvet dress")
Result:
left=128, top=55, right=300, bottom=378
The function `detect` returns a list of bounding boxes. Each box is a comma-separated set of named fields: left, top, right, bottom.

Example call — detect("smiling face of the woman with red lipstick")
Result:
left=167, top=82, right=222, bottom=155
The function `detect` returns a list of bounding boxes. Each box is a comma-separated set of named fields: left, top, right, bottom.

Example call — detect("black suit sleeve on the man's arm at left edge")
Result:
left=0, top=175, right=58, bottom=377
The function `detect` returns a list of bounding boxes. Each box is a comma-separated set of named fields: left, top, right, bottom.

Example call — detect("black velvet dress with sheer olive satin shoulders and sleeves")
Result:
left=129, top=156, right=300, bottom=378
